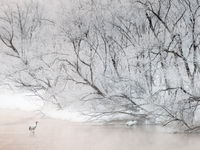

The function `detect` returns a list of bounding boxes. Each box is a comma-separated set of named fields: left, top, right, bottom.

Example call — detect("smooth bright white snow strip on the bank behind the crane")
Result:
left=0, top=90, right=88, bottom=122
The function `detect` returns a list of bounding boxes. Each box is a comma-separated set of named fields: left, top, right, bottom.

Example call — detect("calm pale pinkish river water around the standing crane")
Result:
left=0, top=109, right=200, bottom=150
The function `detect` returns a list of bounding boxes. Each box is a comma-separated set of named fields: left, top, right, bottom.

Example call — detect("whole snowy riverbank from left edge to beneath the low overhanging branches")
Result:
left=0, top=89, right=139, bottom=124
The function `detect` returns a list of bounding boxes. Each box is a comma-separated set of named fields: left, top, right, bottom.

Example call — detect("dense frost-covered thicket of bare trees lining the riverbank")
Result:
left=0, top=0, right=200, bottom=130
